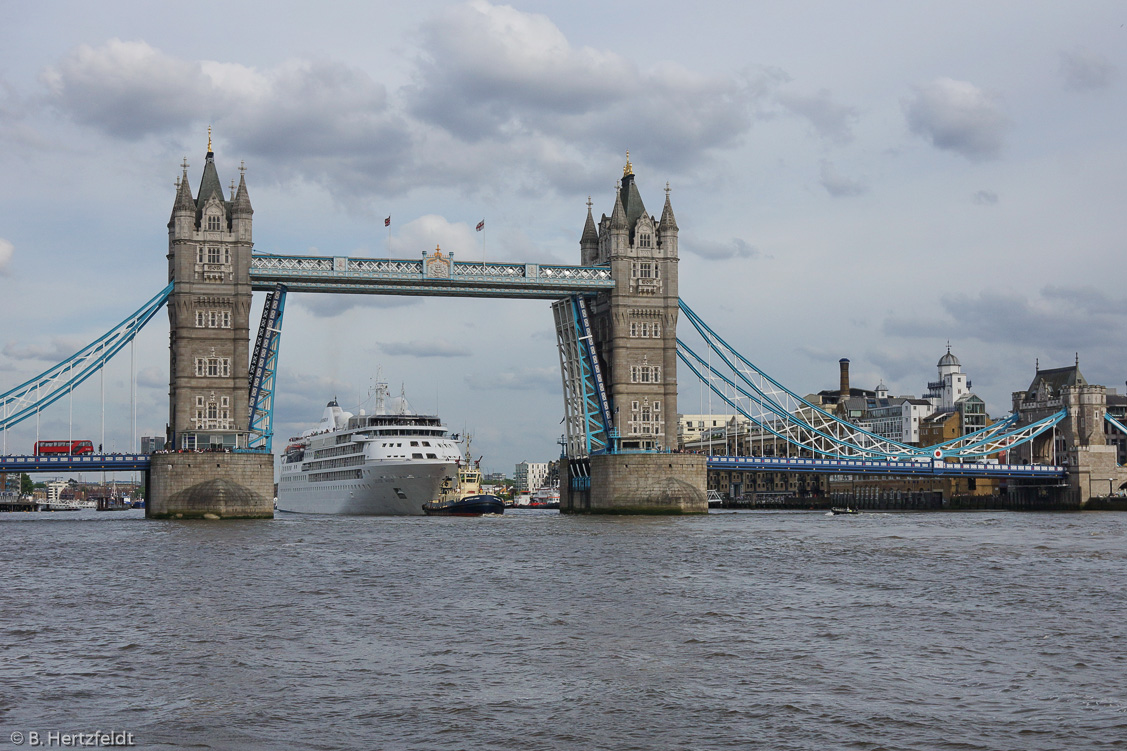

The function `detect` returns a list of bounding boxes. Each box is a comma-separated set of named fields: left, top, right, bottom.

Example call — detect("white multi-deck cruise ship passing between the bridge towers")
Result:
left=277, top=383, right=461, bottom=515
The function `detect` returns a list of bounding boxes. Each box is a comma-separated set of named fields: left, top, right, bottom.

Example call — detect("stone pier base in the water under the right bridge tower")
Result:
left=560, top=453, right=708, bottom=514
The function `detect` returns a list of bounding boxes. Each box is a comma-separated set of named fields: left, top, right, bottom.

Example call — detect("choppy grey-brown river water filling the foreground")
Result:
left=0, top=511, right=1127, bottom=751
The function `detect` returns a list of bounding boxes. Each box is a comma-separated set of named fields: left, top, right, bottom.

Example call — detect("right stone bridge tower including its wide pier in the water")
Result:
left=560, top=152, right=708, bottom=513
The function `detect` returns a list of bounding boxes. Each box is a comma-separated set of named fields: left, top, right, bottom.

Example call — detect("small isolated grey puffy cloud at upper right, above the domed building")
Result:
left=903, top=78, right=1010, bottom=161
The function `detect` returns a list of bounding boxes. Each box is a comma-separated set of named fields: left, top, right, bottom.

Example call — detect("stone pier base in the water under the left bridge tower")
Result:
left=145, top=451, right=274, bottom=519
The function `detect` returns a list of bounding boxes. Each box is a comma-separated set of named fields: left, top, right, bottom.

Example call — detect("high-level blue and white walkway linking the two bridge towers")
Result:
left=250, top=253, right=614, bottom=300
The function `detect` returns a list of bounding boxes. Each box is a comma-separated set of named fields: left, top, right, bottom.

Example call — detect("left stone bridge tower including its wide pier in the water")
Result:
left=148, top=131, right=274, bottom=518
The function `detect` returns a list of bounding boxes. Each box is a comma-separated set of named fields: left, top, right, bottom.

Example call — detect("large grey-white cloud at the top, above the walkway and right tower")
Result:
left=408, top=0, right=764, bottom=167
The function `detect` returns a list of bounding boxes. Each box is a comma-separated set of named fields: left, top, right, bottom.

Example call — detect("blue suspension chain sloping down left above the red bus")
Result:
left=0, top=283, right=172, bottom=430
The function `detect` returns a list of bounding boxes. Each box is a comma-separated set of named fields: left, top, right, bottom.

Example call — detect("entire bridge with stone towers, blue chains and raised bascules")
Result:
left=0, top=142, right=1127, bottom=518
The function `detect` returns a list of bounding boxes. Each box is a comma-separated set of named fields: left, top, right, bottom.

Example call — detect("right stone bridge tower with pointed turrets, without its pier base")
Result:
left=579, top=154, right=678, bottom=450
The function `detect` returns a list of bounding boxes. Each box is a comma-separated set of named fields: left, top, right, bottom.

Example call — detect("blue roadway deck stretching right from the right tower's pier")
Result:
left=708, top=456, right=1066, bottom=479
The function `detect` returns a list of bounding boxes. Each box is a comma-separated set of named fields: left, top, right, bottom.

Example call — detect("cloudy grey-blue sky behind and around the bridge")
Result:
left=0, top=0, right=1127, bottom=474
